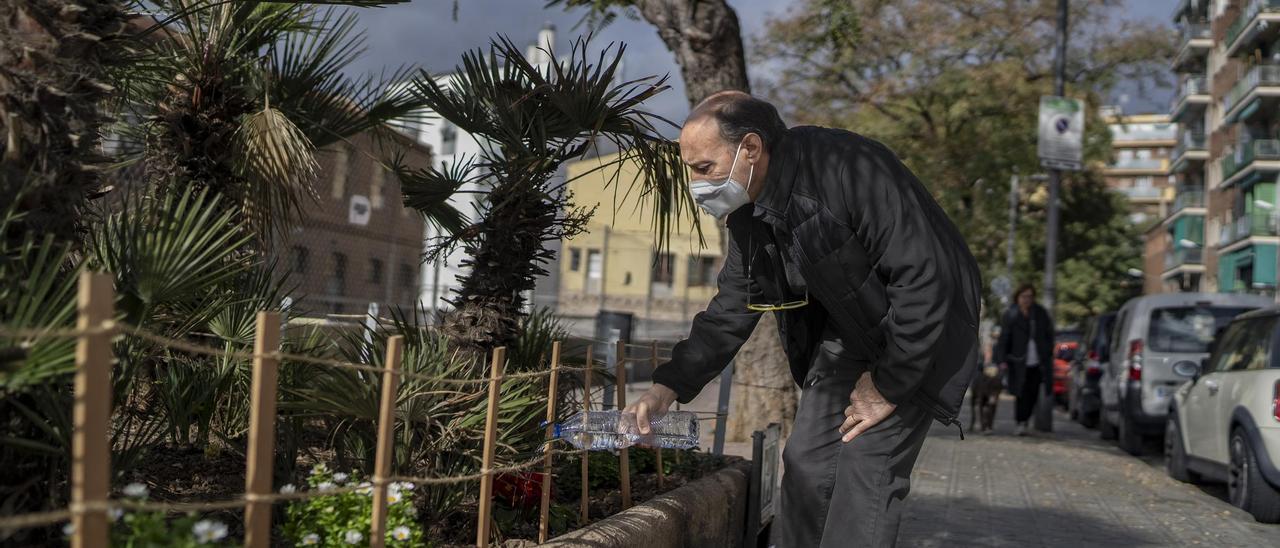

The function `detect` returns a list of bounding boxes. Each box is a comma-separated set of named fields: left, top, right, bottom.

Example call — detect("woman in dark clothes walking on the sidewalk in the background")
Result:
left=995, top=284, right=1053, bottom=435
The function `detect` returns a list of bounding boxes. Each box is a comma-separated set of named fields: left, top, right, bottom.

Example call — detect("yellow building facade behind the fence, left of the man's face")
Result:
left=557, top=154, right=722, bottom=339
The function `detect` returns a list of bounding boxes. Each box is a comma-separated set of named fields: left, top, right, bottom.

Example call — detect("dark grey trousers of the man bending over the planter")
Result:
left=777, top=358, right=931, bottom=548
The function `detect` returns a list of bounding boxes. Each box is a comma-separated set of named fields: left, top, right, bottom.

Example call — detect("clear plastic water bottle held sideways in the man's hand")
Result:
left=554, top=410, right=698, bottom=451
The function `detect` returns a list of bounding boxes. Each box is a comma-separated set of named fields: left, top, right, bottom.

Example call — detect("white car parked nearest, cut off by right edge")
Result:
left=1165, top=309, right=1280, bottom=524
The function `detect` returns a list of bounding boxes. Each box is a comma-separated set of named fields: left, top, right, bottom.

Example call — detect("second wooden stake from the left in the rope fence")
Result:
left=244, top=311, right=280, bottom=548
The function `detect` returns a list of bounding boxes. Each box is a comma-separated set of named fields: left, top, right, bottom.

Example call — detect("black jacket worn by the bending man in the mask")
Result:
left=654, top=127, right=980, bottom=421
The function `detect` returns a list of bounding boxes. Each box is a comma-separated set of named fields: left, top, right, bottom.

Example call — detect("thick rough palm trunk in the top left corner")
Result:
left=0, top=0, right=124, bottom=247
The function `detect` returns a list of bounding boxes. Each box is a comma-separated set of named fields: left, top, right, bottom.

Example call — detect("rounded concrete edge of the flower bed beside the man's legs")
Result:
left=543, top=461, right=751, bottom=548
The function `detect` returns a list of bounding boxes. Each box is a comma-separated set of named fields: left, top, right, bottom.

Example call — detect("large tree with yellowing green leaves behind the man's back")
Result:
left=759, top=0, right=1174, bottom=321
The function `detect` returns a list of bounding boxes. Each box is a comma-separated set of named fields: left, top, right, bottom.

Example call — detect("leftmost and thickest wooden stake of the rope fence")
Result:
left=72, top=271, right=115, bottom=548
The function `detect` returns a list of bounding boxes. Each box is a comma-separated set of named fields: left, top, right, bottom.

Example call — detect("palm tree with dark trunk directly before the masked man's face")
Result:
left=398, top=38, right=696, bottom=358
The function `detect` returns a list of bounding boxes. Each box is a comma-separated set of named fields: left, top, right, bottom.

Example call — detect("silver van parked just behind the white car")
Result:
left=1098, top=293, right=1274, bottom=455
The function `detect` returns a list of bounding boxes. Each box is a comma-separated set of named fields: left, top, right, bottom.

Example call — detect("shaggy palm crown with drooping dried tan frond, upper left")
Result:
left=103, top=0, right=422, bottom=243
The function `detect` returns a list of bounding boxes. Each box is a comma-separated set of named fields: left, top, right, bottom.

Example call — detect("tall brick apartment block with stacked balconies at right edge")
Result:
left=1147, top=0, right=1280, bottom=299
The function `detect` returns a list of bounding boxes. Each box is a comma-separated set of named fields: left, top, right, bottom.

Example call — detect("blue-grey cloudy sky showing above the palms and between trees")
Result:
left=352, top=0, right=1178, bottom=122
